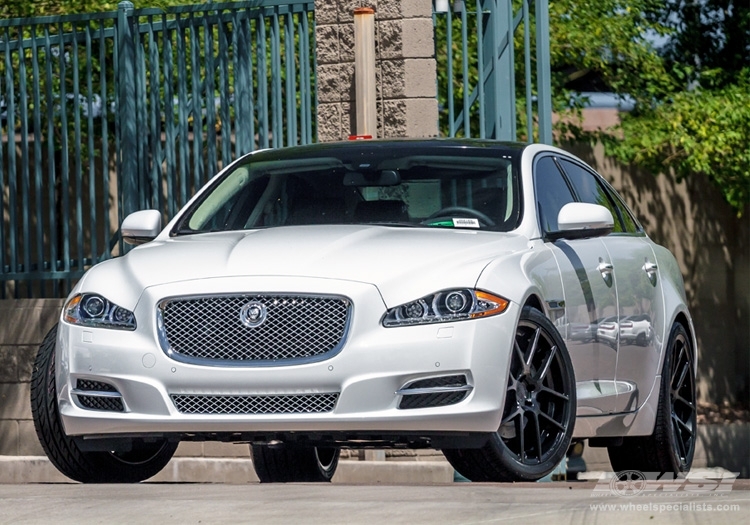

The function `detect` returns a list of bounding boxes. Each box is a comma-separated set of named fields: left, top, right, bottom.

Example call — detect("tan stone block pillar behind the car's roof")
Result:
left=315, top=0, right=438, bottom=142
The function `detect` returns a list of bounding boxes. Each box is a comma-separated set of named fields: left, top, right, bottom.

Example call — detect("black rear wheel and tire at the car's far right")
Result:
left=607, top=323, right=697, bottom=475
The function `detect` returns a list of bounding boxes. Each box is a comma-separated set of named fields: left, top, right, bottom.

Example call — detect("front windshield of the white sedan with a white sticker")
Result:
left=173, top=145, right=520, bottom=235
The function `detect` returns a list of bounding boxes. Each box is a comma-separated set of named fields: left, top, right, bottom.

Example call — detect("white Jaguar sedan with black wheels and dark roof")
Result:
left=31, top=139, right=696, bottom=482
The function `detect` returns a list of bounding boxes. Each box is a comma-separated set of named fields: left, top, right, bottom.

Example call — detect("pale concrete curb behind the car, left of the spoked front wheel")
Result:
left=0, top=456, right=453, bottom=485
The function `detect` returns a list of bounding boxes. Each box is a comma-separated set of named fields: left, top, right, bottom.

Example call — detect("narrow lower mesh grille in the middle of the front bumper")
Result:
left=171, top=393, right=339, bottom=414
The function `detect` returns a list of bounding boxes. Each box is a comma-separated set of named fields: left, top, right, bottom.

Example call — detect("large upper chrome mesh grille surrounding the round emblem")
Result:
left=160, top=295, right=350, bottom=363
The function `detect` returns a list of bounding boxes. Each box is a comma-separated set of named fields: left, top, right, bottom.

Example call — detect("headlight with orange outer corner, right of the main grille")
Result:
left=383, top=288, right=508, bottom=327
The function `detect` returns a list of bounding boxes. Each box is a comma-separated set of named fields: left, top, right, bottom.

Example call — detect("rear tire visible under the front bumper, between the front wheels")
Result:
left=250, top=443, right=340, bottom=483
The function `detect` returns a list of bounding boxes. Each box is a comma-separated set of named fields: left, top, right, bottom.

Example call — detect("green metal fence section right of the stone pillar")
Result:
left=433, top=0, right=552, bottom=144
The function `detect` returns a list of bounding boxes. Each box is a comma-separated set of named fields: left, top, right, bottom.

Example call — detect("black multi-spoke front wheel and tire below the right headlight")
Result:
left=443, top=306, right=576, bottom=481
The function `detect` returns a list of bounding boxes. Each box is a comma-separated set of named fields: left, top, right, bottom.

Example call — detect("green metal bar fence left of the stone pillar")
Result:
left=0, top=0, right=315, bottom=298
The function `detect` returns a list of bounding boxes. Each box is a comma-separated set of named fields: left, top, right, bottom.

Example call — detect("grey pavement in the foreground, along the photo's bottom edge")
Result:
left=0, top=480, right=750, bottom=525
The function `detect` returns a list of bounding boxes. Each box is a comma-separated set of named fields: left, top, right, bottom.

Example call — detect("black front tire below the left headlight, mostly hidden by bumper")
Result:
left=31, top=325, right=178, bottom=483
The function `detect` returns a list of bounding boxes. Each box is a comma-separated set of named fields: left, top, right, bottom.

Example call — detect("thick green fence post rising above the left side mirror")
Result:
left=117, top=0, right=139, bottom=217
